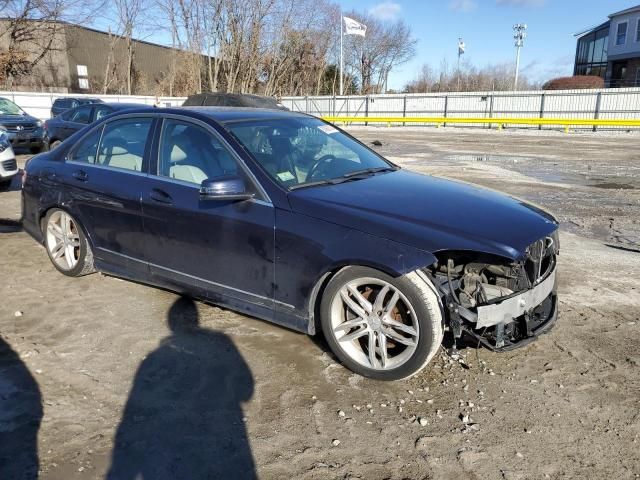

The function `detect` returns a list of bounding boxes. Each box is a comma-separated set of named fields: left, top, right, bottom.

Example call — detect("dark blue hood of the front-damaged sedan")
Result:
left=289, top=170, right=557, bottom=260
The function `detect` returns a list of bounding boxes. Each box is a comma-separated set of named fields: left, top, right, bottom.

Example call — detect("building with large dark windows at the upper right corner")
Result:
left=573, top=5, right=640, bottom=87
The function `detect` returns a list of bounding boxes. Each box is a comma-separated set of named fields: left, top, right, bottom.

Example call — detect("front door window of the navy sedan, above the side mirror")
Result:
left=158, top=119, right=241, bottom=185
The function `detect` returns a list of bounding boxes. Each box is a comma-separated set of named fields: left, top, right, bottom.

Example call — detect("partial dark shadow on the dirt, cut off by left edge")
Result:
left=0, top=336, right=42, bottom=480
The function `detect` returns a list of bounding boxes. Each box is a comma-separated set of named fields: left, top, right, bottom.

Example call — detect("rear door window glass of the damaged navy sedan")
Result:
left=98, top=118, right=153, bottom=172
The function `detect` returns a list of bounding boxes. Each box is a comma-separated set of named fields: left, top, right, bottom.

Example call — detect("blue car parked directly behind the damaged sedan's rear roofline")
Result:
left=44, top=103, right=151, bottom=150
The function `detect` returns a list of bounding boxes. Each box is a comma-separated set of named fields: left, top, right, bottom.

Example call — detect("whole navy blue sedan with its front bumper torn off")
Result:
left=22, top=108, right=559, bottom=380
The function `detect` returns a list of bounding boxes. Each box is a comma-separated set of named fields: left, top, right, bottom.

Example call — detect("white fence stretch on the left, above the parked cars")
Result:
left=0, top=92, right=185, bottom=120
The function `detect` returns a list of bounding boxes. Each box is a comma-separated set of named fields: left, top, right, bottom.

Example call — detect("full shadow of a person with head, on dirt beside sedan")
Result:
left=107, top=297, right=256, bottom=480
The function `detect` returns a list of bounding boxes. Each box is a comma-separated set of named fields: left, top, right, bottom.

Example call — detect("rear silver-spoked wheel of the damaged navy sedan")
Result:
left=42, top=208, right=95, bottom=277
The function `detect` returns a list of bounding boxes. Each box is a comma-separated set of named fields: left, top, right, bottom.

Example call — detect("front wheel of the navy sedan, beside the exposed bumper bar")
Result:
left=320, top=266, right=444, bottom=380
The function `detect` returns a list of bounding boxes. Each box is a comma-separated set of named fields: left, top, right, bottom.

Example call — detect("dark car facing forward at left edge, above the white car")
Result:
left=0, top=97, right=44, bottom=153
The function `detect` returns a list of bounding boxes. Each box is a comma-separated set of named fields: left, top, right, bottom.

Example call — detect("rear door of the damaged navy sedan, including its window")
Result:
left=64, top=115, right=155, bottom=276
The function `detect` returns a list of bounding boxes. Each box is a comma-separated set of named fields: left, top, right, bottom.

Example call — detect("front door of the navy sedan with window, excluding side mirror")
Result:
left=142, top=118, right=275, bottom=317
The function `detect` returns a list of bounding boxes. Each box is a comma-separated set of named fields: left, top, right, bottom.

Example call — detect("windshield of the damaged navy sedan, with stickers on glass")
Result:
left=226, top=118, right=396, bottom=189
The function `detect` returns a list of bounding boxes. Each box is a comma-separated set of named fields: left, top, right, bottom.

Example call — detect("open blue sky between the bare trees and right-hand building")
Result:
left=339, top=0, right=638, bottom=89
